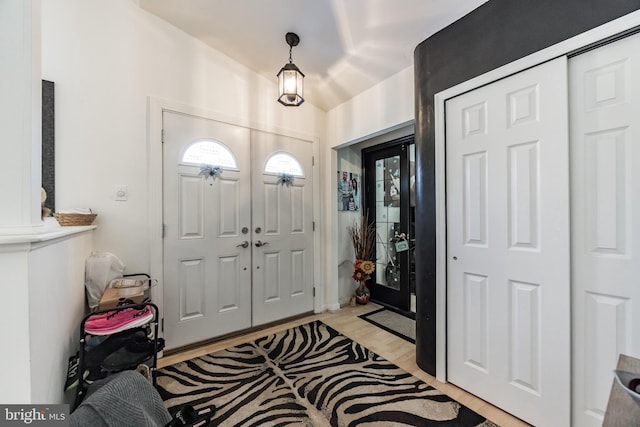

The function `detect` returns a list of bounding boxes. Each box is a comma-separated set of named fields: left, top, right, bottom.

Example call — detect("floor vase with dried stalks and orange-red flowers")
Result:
left=349, top=215, right=376, bottom=304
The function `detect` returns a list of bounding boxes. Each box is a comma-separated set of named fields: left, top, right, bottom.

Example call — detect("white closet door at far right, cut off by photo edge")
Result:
left=569, top=31, right=640, bottom=427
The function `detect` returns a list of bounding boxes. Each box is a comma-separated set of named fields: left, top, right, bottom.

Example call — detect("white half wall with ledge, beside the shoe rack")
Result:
left=0, top=227, right=93, bottom=404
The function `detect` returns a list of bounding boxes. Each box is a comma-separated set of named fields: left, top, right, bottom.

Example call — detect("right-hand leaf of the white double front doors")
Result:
left=251, top=131, right=313, bottom=325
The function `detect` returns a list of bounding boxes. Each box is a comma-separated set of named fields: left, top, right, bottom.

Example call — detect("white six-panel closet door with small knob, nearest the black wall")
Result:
left=446, top=58, right=571, bottom=426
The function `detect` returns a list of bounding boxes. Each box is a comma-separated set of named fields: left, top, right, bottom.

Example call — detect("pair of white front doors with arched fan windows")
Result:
left=163, top=111, right=313, bottom=349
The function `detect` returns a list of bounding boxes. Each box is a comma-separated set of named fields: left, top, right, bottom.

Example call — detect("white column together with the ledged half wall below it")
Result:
left=0, top=0, right=91, bottom=404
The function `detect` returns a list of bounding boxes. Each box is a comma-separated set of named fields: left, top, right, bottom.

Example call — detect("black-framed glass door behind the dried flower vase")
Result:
left=363, top=135, right=415, bottom=312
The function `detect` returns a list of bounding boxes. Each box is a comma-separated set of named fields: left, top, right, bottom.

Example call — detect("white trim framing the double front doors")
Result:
left=147, top=96, right=325, bottom=328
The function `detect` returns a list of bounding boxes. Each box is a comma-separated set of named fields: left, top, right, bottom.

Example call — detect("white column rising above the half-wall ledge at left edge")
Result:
left=0, top=0, right=42, bottom=235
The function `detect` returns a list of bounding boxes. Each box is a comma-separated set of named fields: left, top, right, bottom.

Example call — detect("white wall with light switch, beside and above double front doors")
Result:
left=42, top=0, right=325, bottom=273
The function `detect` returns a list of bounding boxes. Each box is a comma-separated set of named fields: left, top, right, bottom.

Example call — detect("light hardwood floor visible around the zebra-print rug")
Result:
left=158, top=303, right=529, bottom=427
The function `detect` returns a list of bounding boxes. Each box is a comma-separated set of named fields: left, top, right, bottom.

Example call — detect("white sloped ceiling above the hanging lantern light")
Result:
left=139, top=0, right=487, bottom=111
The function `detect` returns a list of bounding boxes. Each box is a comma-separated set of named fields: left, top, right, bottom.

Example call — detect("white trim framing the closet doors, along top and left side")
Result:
left=434, top=11, right=640, bottom=382
